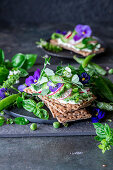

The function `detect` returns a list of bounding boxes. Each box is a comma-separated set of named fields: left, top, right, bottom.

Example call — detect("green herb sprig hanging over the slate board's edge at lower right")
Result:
left=93, top=123, right=113, bottom=153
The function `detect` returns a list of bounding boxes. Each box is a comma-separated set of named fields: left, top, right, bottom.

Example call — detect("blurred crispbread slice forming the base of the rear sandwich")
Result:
left=50, top=39, right=105, bottom=57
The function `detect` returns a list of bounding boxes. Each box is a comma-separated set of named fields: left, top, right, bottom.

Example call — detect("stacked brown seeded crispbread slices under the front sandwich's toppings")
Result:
left=24, top=88, right=96, bottom=123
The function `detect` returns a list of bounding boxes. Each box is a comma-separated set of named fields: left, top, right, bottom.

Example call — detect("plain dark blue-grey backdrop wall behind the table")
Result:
left=0, top=0, right=113, bottom=26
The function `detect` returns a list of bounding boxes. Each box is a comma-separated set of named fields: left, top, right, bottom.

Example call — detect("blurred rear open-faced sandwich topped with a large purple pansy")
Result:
left=39, top=25, right=104, bottom=56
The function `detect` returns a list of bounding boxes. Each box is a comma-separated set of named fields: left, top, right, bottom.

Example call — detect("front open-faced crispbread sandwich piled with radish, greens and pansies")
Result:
left=24, top=57, right=99, bottom=123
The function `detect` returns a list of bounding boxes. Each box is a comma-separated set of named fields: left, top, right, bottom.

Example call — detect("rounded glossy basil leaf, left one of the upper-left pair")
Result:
left=12, top=53, right=26, bottom=68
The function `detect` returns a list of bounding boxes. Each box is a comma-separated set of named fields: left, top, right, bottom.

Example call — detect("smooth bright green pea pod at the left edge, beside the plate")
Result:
left=0, top=94, right=20, bottom=111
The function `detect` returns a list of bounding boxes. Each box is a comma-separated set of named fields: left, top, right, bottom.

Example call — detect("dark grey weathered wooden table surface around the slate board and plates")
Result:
left=0, top=23, right=113, bottom=170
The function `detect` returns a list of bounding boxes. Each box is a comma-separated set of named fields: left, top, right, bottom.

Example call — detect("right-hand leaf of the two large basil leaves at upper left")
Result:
left=22, top=54, right=37, bottom=70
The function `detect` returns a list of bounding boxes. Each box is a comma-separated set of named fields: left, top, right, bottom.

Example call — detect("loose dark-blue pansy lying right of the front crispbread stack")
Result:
left=91, top=108, right=105, bottom=123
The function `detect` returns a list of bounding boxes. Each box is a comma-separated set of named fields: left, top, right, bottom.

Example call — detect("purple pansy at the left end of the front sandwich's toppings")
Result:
left=25, top=69, right=41, bottom=86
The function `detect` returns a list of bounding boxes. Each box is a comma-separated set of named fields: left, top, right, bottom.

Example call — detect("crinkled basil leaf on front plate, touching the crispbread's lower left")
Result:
left=34, top=109, right=49, bottom=120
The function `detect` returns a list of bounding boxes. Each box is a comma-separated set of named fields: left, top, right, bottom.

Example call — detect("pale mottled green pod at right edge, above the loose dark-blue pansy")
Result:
left=97, top=102, right=113, bottom=111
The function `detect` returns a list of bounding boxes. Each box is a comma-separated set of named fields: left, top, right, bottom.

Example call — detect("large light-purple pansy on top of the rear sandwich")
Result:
left=73, top=24, right=92, bottom=41
